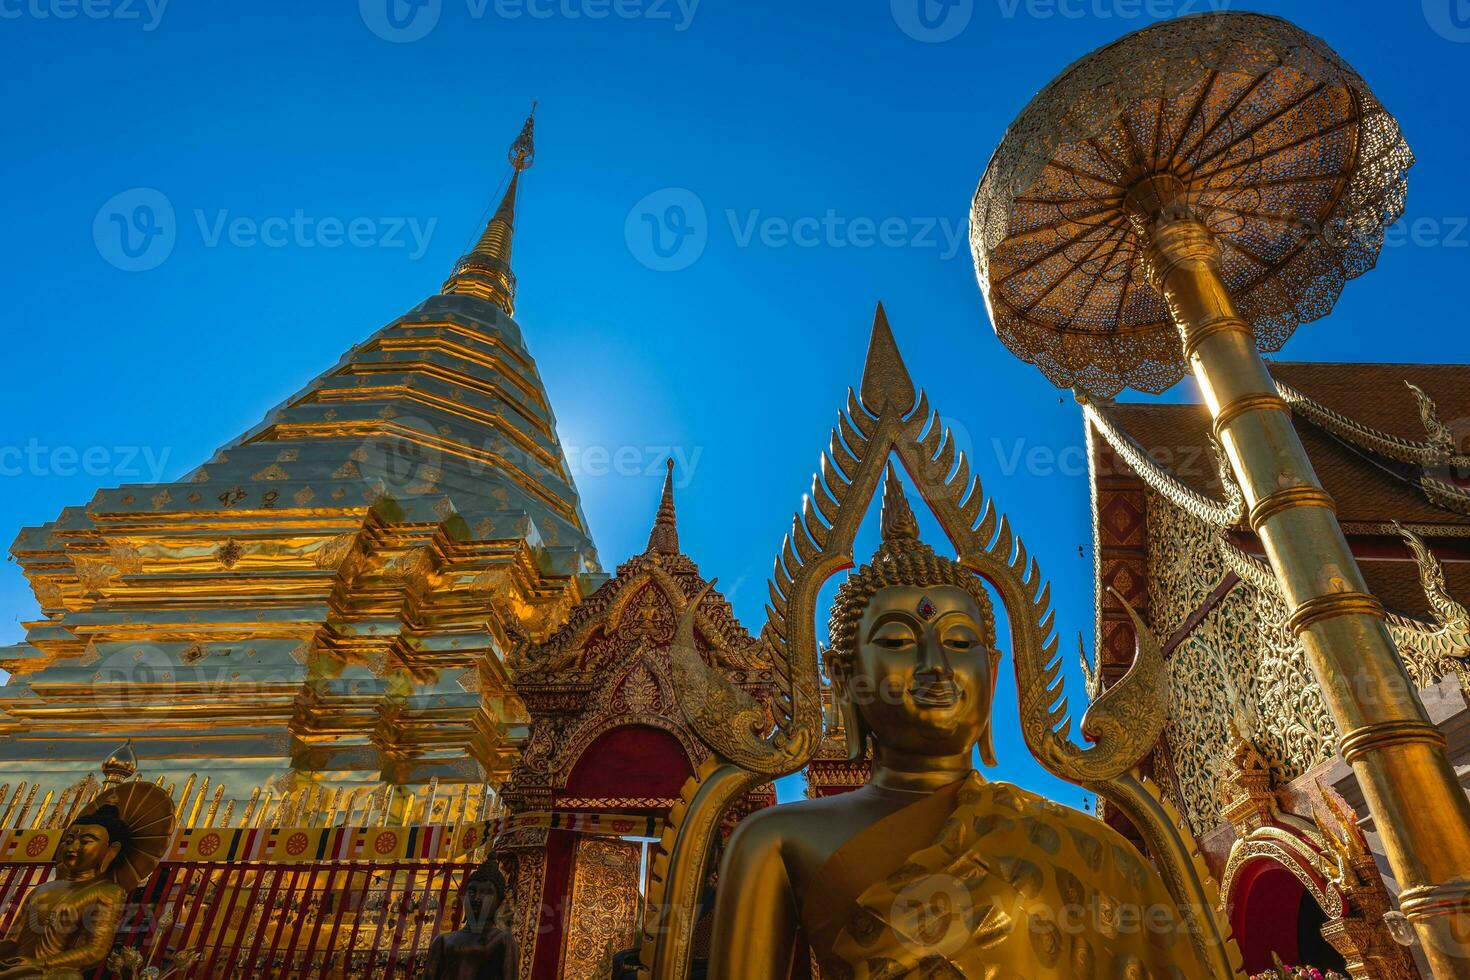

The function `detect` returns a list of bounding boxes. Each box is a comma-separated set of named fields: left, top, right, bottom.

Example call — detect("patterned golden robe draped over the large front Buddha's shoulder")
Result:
left=803, top=773, right=1210, bottom=980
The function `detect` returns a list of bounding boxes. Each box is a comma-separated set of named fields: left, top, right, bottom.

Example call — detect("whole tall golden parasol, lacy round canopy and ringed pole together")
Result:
left=970, top=12, right=1470, bottom=976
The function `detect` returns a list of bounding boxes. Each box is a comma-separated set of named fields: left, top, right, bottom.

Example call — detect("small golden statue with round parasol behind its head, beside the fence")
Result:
left=0, top=783, right=173, bottom=980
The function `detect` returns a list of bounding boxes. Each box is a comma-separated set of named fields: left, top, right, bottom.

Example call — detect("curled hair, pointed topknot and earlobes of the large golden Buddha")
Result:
left=823, top=463, right=998, bottom=765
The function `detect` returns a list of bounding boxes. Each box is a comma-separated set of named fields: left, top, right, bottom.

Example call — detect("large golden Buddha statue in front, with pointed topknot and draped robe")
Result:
left=710, top=467, right=1208, bottom=980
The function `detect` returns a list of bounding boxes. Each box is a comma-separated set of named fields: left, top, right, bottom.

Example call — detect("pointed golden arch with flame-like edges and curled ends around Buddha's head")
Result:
left=672, top=311, right=1167, bottom=783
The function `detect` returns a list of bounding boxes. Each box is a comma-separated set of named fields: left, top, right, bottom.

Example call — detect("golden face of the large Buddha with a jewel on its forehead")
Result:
left=845, top=585, right=995, bottom=755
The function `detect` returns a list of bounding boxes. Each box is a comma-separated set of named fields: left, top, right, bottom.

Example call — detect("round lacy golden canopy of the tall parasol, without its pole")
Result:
left=970, top=12, right=1413, bottom=395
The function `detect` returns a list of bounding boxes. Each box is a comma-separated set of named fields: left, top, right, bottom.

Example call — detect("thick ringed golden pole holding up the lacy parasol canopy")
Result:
left=1125, top=175, right=1470, bottom=977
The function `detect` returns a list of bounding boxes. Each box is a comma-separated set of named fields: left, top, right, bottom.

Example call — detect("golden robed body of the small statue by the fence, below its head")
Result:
left=0, top=879, right=128, bottom=980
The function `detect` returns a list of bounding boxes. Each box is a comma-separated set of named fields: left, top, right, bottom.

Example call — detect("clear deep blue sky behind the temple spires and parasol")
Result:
left=0, top=0, right=1470, bottom=802
